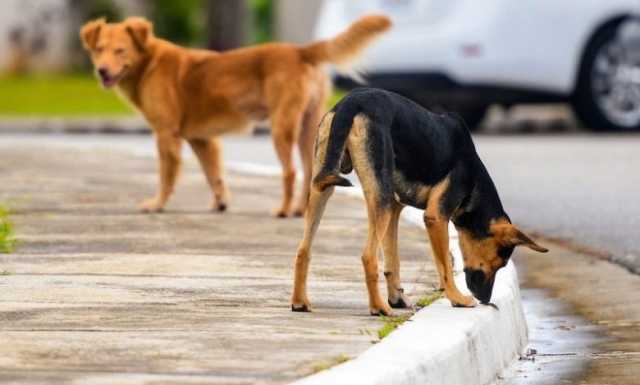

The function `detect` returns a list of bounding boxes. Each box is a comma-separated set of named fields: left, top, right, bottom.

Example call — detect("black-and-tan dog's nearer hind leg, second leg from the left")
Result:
left=347, top=115, right=393, bottom=315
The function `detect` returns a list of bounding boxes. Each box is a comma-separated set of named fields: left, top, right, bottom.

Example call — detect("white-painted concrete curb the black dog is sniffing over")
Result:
left=229, top=163, right=528, bottom=385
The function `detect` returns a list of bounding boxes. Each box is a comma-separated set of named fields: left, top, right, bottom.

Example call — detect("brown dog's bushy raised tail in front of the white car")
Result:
left=301, top=15, right=391, bottom=67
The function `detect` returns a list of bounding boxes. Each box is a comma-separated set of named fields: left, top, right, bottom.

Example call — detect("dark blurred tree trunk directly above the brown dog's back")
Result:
left=207, top=0, right=249, bottom=51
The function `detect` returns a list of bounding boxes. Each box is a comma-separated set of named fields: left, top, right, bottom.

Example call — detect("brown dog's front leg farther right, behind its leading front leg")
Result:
left=189, top=138, right=229, bottom=211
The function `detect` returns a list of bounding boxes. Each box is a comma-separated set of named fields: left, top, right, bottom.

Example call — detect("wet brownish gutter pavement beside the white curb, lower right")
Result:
left=499, top=241, right=640, bottom=385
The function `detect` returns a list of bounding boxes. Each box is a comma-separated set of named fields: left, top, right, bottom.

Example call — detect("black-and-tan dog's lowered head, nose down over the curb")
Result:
left=459, top=220, right=549, bottom=304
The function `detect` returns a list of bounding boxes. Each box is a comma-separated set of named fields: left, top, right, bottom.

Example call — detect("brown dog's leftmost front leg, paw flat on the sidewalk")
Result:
left=140, top=131, right=182, bottom=212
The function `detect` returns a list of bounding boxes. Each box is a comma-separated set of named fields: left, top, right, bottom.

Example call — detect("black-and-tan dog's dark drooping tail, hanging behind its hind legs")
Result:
left=312, top=105, right=355, bottom=191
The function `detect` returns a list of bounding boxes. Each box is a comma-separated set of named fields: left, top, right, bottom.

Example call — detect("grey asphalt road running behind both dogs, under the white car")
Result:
left=0, top=133, right=640, bottom=272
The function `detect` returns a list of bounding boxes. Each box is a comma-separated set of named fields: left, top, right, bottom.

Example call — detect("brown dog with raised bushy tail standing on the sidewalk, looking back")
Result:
left=80, top=15, right=391, bottom=217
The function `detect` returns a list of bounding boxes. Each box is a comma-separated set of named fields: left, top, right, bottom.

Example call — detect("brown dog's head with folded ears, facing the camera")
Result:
left=80, top=17, right=153, bottom=88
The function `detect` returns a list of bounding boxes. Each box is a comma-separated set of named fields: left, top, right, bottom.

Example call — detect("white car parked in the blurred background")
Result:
left=316, top=0, right=640, bottom=130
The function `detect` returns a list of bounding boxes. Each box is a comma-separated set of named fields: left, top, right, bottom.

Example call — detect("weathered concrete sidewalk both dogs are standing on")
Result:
left=0, top=147, right=437, bottom=384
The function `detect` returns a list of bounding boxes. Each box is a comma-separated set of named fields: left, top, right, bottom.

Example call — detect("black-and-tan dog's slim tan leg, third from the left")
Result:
left=382, top=202, right=411, bottom=309
